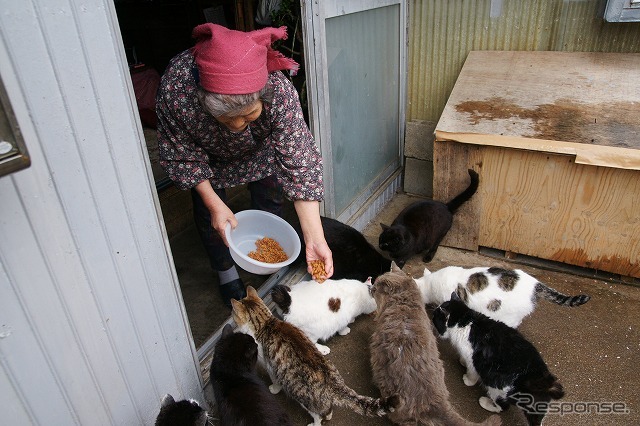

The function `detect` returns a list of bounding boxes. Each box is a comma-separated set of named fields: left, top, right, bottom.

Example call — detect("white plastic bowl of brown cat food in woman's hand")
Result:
left=224, top=210, right=301, bottom=275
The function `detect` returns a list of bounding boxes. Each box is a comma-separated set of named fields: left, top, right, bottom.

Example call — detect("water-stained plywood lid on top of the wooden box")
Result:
left=435, top=51, right=640, bottom=170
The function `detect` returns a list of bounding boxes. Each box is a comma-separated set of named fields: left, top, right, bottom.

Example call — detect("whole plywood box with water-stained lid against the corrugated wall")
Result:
left=433, top=52, right=640, bottom=277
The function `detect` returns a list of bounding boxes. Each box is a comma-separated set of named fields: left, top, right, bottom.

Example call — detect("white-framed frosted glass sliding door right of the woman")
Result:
left=303, top=0, right=406, bottom=222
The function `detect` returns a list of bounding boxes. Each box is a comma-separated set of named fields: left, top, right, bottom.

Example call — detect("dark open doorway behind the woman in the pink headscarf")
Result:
left=115, top=0, right=304, bottom=352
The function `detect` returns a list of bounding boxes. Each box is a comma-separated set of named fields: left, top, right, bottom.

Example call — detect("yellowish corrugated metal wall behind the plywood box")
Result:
left=407, top=0, right=640, bottom=121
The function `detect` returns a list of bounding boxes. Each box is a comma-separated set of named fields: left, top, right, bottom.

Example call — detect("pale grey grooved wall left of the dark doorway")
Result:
left=0, top=0, right=202, bottom=425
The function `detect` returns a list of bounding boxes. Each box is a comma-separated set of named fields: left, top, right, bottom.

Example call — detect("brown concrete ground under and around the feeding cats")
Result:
left=172, top=194, right=640, bottom=426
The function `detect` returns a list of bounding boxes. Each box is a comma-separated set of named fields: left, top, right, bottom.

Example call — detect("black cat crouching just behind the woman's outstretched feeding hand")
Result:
left=293, top=216, right=391, bottom=281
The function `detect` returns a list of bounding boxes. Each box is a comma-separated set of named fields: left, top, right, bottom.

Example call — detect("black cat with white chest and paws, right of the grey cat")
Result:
left=433, top=293, right=564, bottom=425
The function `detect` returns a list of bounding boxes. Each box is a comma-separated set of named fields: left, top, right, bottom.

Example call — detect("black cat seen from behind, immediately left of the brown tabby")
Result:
left=210, top=324, right=293, bottom=426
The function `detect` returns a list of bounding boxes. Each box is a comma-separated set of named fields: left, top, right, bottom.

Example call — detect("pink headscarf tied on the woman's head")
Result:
left=192, top=23, right=299, bottom=95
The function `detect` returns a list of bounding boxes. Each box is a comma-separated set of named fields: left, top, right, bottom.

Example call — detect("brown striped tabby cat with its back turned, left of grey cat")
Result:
left=231, top=286, right=398, bottom=426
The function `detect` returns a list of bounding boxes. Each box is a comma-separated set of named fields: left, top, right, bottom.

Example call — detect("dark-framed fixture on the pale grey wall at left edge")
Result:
left=0, top=75, right=31, bottom=177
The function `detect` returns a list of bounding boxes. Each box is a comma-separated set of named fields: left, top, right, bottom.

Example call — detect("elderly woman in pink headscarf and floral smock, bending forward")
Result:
left=156, top=24, right=333, bottom=306
